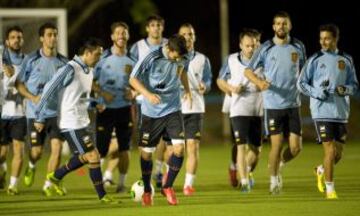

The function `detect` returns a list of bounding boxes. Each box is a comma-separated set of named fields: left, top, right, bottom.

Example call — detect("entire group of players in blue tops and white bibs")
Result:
left=0, top=9, right=358, bottom=206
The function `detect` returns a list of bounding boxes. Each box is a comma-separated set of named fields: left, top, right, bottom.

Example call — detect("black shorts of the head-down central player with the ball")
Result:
left=139, top=111, right=185, bottom=147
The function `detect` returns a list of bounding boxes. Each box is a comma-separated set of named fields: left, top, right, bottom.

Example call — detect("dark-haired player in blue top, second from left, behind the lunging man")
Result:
left=16, top=23, right=68, bottom=196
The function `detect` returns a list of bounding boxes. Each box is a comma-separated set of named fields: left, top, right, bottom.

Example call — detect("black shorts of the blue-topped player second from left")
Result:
left=27, top=117, right=64, bottom=146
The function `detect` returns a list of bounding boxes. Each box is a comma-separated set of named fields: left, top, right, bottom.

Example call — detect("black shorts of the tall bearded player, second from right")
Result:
left=264, top=108, right=302, bottom=137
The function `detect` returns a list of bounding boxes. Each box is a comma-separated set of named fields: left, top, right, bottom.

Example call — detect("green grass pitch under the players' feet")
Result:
left=0, top=142, right=360, bottom=216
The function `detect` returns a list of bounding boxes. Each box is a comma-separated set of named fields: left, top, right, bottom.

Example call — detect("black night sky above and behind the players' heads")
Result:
left=70, top=0, right=360, bottom=80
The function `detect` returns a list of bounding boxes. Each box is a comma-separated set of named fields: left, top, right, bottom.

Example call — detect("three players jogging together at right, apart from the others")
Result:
left=217, top=12, right=358, bottom=199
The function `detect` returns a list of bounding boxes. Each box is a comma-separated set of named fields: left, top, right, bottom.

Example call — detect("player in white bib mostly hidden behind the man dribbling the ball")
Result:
left=130, top=15, right=168, bottom=188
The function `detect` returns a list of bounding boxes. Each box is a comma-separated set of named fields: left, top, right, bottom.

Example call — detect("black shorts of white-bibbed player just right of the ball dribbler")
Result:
left=183, top=113, right=203, bottom=140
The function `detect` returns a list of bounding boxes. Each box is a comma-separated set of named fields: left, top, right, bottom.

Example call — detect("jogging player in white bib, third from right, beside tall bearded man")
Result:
left=217, top=29, right=263, bottom=193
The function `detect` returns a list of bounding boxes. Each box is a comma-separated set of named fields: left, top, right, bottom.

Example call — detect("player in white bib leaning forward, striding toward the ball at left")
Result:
left=34, top=39, right=113, bottom=203
